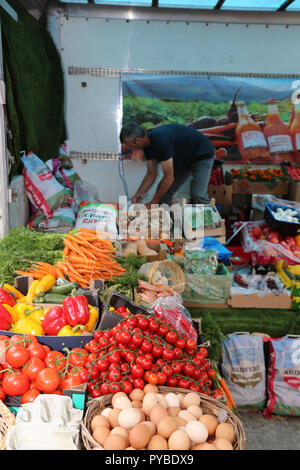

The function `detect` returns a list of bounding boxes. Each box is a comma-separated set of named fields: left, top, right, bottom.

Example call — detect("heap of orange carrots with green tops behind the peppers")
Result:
left=16, top=228, right=126, bottom=287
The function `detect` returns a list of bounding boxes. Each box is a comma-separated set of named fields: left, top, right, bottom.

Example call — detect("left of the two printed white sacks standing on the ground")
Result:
left=222, top=332, right=267, bottom=409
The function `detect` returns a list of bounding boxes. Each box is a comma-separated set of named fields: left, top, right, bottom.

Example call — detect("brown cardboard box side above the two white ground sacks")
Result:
left=228, top=292, right=292, bottom=310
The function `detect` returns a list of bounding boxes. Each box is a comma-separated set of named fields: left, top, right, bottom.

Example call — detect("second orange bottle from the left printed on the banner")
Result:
left=264, top=99, right=294, bottom=163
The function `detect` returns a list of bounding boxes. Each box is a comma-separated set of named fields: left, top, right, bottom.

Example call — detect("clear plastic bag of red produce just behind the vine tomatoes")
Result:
left=153, top=294, right=198, bottom=342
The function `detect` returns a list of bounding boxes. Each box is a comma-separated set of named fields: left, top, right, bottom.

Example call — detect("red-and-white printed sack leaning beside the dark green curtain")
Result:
left=21, top=152, right=70, bottom=219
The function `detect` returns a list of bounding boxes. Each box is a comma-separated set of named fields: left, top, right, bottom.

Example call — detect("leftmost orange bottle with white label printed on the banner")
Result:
left=235, top=101, right=271, bottom=162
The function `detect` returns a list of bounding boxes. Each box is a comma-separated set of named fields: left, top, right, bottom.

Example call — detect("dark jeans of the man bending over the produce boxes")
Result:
left=160, top=155, right=215, bottom=206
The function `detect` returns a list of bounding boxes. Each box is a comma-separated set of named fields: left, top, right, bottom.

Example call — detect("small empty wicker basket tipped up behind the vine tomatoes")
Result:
left=139, top=260, right=185, bottom=294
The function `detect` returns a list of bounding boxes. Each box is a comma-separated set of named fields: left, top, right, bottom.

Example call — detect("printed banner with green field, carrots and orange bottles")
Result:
left=121, top=73, right=300, bottom=164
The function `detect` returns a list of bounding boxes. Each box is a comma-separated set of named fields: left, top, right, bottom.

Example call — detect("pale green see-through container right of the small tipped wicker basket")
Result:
left=182, top=264, right=233, bottom=307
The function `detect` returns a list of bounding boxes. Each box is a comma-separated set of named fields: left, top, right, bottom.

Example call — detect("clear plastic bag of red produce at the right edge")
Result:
left=241, top=220, right=300, bottom=264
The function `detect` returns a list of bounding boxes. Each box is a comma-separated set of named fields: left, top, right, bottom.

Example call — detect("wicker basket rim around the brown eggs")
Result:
left=81, top=386, right=246, bottom=450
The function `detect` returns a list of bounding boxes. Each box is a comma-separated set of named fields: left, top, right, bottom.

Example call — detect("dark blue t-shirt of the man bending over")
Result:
left=144, top=124, right=215, bottom=170
